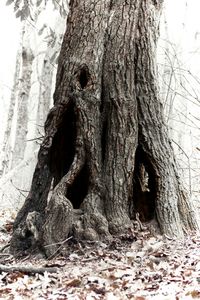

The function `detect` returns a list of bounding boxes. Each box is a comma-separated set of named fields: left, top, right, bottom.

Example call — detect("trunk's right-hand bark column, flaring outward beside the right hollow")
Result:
left=136, top=2, right=197, bottom=236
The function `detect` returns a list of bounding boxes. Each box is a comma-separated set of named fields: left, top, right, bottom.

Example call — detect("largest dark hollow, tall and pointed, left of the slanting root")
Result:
left=49, top=103, right=76, bottom=187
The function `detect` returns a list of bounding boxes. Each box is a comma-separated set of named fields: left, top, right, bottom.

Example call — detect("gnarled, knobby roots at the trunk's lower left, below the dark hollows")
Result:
left=10, top=193, right=112, bottom=257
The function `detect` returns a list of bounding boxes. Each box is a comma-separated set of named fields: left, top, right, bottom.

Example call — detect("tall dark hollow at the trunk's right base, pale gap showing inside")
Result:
left=132, top=146, right=156, bottom=222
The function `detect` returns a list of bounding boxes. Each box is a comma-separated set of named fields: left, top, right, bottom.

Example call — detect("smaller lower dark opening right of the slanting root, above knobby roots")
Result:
left=66, top=164, right=89, bottom=209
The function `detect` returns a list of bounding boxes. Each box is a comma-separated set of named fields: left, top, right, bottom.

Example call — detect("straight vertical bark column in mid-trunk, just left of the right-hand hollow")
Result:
left=103, top=1, right=140, bottom=231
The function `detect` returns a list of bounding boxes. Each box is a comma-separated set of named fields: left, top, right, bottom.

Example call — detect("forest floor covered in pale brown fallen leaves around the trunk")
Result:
left=0, top=212, right=200, bottom=300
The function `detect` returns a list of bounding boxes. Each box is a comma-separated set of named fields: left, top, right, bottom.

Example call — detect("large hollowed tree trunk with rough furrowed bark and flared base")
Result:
left=11, top=0, right=198, bottom=255
